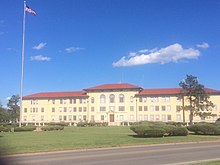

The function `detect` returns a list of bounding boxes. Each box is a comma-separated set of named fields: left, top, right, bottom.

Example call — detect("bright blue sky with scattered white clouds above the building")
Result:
left=0, top=0, right=220, bottom=104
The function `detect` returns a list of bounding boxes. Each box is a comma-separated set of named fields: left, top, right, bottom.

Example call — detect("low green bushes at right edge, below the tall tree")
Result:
left=187, top=122, right=220, bottom=135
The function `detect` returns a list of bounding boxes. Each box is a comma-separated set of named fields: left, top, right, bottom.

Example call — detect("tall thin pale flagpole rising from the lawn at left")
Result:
left=19, top=1, right=26, bottom=127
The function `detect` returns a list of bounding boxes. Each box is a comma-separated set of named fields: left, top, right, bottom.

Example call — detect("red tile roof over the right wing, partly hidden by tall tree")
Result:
left=138, top=88, right=220, bottom=95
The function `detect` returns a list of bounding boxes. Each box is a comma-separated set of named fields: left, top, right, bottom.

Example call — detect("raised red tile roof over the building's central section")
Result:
left=84, top=83, right=142, bottom=91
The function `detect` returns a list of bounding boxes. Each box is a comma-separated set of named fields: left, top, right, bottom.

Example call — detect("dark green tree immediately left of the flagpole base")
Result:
left=7, top=95, right=20, bottom=122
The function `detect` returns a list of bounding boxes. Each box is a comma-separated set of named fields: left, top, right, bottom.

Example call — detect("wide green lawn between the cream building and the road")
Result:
left=0, top=127, right=220, bottom=154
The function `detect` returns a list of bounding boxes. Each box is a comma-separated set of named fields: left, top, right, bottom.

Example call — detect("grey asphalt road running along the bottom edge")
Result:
left=1, top=141, right=220, bottom=165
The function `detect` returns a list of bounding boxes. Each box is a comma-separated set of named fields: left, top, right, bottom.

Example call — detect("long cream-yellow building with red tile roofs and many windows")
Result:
left=21, top=83, right=220, bottom=125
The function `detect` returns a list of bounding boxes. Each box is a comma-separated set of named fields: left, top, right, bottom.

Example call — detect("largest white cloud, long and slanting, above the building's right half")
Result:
left=112, top=43, right=200, bottom=67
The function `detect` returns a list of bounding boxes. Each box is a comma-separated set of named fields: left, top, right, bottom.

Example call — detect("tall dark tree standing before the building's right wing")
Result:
left=179, top=75, right=213, bottom=125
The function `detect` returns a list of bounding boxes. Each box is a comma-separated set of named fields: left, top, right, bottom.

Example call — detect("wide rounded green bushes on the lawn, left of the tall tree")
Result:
left=130, top=122, right=188, bottom=137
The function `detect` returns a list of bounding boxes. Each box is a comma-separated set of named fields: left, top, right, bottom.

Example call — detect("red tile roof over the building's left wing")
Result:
left=23, top=91, right=88, bottom=99
